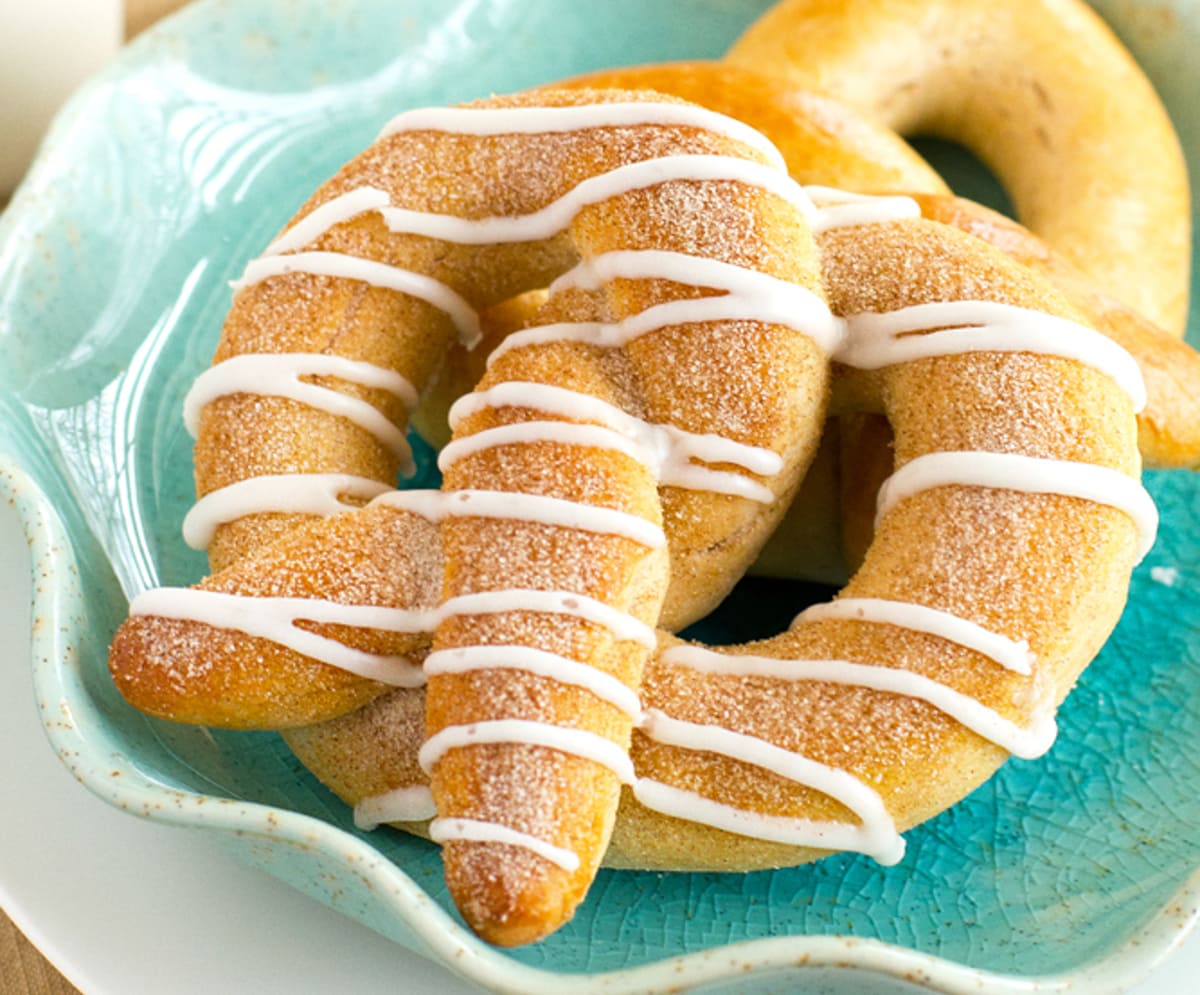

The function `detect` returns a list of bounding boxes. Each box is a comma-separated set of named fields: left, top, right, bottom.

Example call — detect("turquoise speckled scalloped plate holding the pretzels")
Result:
left=0, top=0, right=1200, bottom=995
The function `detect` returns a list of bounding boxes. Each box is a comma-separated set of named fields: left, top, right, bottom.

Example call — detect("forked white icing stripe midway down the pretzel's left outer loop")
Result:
left=184, top=353, right=416, bottom=466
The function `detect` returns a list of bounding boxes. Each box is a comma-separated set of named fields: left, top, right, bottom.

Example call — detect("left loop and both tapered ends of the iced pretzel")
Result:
left=110, top=90, right=836, bottom=943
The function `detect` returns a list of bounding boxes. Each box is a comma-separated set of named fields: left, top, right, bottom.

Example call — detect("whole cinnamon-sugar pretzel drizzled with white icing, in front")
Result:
left=110, top=89, right=1156, bottom=943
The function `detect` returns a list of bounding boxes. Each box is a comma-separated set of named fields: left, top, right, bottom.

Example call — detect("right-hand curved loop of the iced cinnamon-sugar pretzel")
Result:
left=287, top=198, right=1154, bottom=888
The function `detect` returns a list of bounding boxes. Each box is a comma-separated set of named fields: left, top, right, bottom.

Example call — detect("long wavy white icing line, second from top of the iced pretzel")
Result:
left=380, top=154, right=815, bottom=247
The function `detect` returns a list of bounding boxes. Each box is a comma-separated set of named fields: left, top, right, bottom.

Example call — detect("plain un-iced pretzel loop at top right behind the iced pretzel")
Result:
left=727, top=0, right=1192, bottom=336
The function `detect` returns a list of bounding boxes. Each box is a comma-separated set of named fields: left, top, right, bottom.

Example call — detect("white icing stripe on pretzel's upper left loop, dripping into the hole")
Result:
left=230, top=250, right=484, bottom=348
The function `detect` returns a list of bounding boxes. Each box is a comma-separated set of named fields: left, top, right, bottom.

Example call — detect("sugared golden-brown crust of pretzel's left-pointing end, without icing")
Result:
left=109, top=508, right=442, bottom=729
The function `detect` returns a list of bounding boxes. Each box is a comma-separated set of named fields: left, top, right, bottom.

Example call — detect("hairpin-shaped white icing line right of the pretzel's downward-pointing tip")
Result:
left=634, top=709, right=904, bottom=863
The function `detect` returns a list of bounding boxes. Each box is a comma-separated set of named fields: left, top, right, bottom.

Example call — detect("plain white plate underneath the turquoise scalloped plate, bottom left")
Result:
left=0, top=496, right=1200, bottom=995
